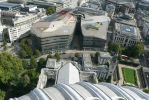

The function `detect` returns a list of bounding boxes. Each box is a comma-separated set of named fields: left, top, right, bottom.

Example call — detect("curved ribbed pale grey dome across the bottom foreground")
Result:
left=9, top=82, right=149, bottom=100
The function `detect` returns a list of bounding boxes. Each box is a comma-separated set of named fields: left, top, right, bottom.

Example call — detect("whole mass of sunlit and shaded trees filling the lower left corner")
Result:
left=0, top=52, right=40, bottom=100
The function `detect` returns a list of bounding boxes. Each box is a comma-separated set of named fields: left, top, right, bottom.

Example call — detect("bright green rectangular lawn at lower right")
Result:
left=122, top=68, right=137, bottom=85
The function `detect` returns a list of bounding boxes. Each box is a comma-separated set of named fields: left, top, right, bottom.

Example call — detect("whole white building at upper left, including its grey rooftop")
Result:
left=1, top=9, right=45, bottom=42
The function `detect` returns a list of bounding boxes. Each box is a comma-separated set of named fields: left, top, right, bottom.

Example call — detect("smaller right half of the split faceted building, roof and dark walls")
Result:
left=81, top=9, right=110, bottom=50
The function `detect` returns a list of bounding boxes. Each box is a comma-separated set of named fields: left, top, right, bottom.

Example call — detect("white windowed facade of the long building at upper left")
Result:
left=7, top=8, right=45, bottom=42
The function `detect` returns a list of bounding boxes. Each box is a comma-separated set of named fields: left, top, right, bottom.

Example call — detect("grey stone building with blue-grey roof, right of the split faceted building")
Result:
left=112, top=23, right=141, bottom=47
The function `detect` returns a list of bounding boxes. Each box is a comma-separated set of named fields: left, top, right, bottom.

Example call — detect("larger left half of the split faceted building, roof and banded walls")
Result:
left=31, top=9, right=76, bottom=53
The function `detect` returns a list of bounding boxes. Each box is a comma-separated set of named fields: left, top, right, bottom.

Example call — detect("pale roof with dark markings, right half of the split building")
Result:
left=81, top=14, right=110, bottom=40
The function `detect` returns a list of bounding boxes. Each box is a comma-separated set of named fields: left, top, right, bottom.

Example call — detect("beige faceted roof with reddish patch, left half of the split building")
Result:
left=31, top=9, right=76, bottom=38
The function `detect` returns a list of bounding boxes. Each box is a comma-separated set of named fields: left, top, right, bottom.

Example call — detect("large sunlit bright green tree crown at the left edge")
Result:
left=0, top=53, right=24, bottom=85
